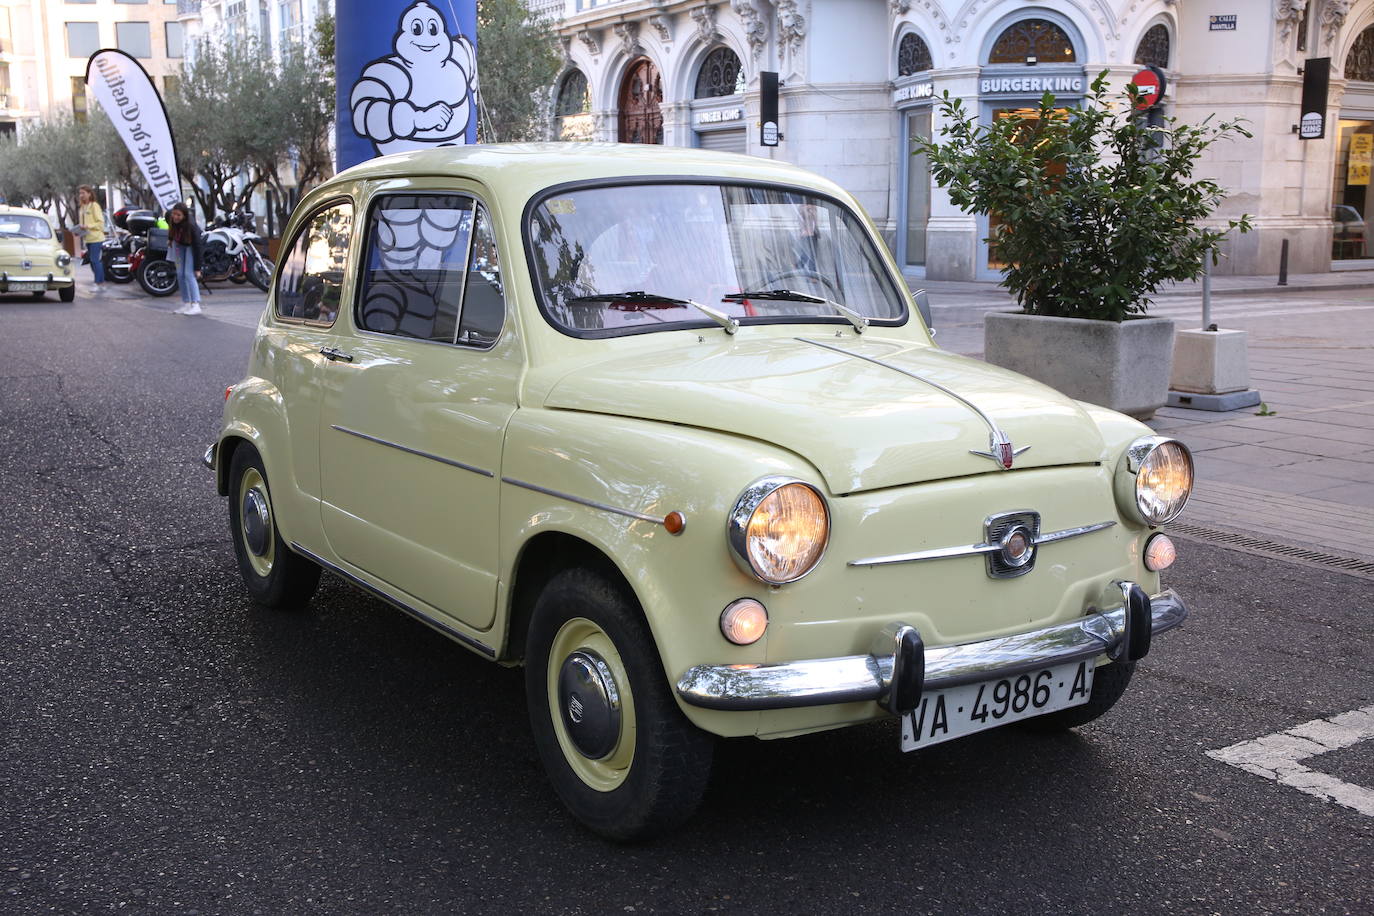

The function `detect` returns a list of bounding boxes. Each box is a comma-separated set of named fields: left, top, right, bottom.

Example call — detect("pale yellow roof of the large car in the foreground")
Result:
left=328, top=141, right=848, bottom=204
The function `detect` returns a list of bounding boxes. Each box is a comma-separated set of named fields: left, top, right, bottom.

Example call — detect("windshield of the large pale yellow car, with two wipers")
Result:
left=526, top=183, right=907, bottom=336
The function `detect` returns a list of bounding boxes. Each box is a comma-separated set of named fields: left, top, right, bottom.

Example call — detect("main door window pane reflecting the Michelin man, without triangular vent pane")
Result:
left=357, top=194, right=474, bottom=343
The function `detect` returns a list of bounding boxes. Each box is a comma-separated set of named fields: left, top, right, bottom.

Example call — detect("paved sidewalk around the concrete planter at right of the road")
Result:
left=911, top=271, right=1374, bottom=560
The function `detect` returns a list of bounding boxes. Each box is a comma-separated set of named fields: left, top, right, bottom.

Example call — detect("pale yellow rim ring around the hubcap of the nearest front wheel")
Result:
left=544, top=617, right=636, bottom=792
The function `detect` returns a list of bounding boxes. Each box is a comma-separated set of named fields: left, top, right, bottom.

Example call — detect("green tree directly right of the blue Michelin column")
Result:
left=477, top=0, right=561, bottom=143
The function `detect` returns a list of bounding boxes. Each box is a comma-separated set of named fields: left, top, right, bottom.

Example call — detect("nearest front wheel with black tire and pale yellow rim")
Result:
left=525, top=569, right=714, bottom=840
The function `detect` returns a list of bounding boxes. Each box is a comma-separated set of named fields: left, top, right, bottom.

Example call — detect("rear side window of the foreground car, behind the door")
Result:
left=276, top=202, right=353, bottom=324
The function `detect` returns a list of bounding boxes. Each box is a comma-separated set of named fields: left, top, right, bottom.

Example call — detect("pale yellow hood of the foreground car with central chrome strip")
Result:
left=545, top=336, right=1105, bottom=493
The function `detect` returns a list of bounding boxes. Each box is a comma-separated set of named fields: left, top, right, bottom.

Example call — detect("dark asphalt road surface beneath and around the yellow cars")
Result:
left=0, top=292, right=1374, bottom=915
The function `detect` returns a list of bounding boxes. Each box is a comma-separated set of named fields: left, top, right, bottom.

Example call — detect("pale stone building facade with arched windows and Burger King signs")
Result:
left=541, top=0, right=1374, bottom=279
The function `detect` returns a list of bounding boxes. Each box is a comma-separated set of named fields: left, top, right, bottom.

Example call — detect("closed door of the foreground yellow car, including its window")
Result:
left=320, top=181, right=523, bottom=629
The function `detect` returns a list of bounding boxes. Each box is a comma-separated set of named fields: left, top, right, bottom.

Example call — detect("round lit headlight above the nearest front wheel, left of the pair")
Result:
left=728, top=477, right=830, bottom=585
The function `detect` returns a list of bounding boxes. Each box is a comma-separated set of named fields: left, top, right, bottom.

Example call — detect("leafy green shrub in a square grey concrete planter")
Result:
left=918, top=71, right=1250, bottom=419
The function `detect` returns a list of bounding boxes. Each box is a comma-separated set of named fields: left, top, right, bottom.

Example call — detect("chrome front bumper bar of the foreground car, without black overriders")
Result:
left=677, top=589, right=1189, bottom=711
